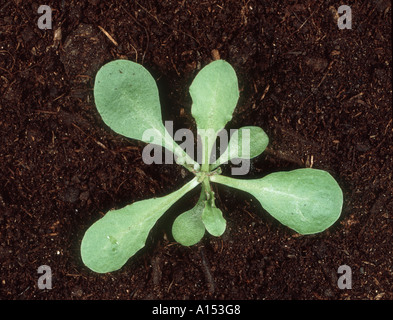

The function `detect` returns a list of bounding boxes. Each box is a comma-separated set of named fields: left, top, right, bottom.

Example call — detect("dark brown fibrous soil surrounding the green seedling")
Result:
left=0, top=0, right=393, bottom=300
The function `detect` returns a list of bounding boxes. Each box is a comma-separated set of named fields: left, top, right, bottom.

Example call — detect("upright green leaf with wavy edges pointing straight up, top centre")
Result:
left=190, top=60, right=239, bottom=171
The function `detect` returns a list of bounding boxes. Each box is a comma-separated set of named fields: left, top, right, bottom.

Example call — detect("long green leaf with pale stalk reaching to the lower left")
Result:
left=81, top=178, right=198, bottom=273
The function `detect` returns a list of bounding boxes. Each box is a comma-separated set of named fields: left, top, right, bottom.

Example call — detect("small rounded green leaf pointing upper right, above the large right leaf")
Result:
left=211, top=126, right=269, bottom=170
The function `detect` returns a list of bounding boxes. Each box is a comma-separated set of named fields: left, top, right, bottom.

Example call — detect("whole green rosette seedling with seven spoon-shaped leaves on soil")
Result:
left=81, top=60, right=343, bottom=273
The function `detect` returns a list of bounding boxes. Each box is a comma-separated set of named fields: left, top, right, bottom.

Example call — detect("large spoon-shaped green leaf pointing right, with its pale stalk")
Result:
left=210, top=168, right=343, bottom=234
